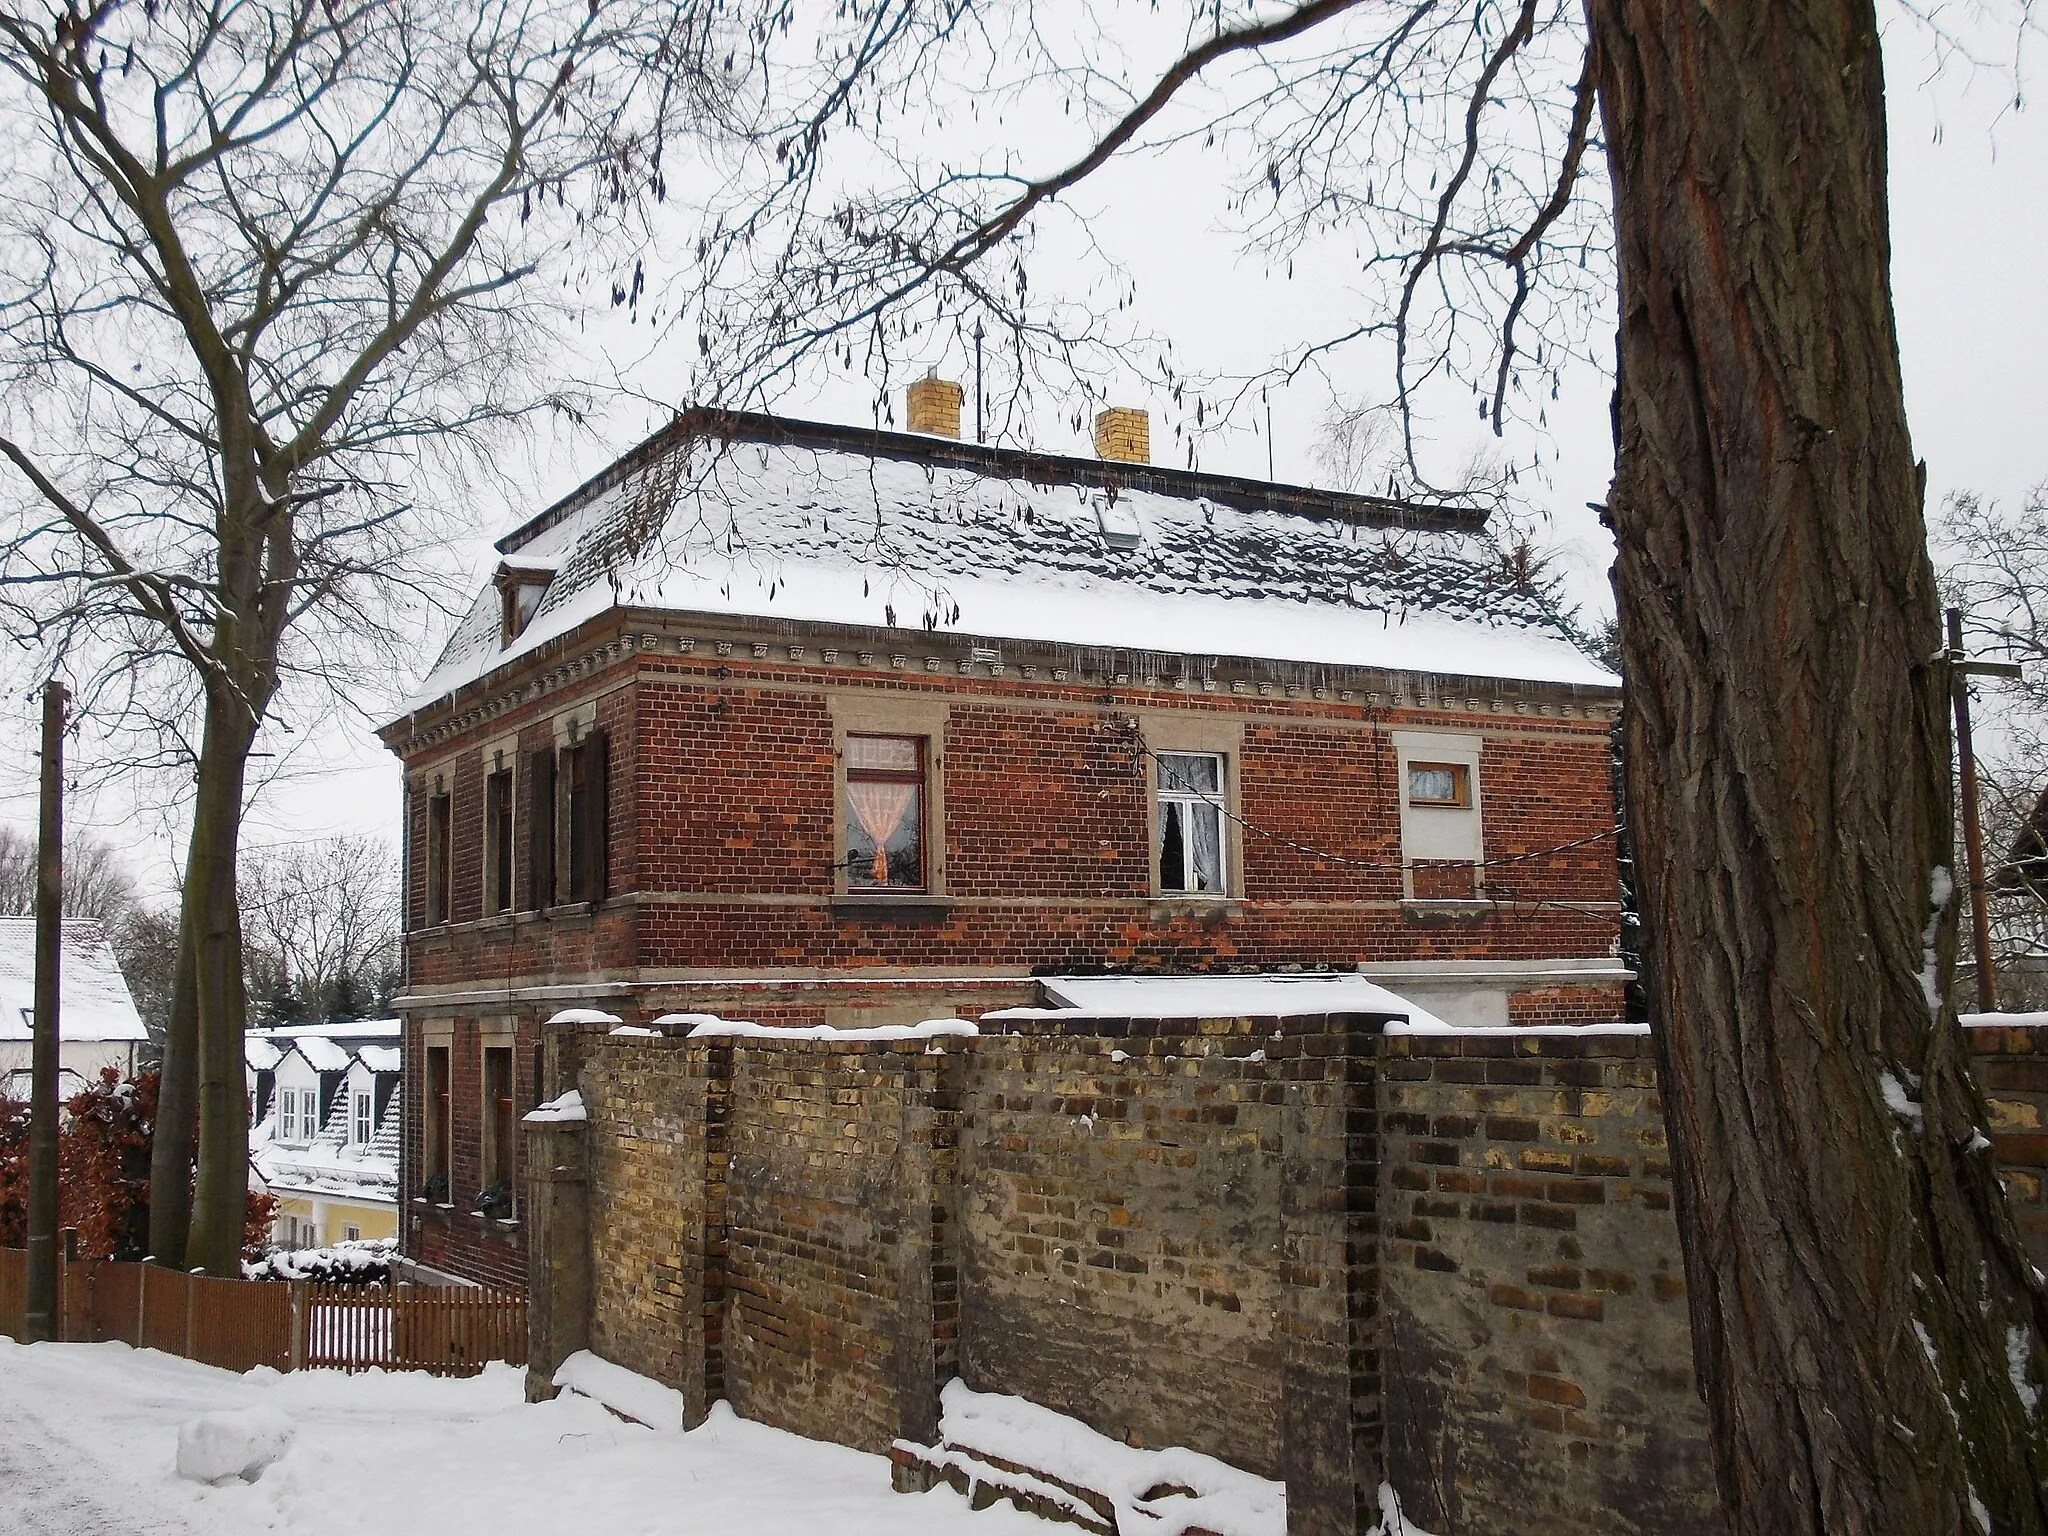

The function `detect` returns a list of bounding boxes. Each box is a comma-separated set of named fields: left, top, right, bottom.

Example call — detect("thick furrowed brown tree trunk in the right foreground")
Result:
left=1587, top=0, right=2048, bottom=1536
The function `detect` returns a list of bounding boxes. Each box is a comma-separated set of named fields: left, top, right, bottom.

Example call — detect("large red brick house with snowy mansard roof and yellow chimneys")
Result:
left=383, top=379, right=1626, bottom=1284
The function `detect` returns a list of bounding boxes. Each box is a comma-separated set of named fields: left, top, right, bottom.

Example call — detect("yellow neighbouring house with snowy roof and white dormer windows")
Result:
left=244, top=1018, right=401, bottom=1247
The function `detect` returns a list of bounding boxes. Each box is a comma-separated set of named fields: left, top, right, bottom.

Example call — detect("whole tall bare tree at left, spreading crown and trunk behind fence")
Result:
left=0, top=0, right=729, bottom=1274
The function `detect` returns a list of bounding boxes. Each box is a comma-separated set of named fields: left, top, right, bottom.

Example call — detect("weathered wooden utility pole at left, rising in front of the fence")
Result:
left=23, top=678, right=72, bottom=1343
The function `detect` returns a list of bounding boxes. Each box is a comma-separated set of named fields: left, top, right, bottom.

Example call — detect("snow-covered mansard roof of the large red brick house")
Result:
left=410, top=412, right=1616, bottom=707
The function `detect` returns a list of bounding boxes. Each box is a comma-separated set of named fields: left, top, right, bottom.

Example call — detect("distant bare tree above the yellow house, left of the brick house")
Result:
left=242, top=838, right=399, bottom=1022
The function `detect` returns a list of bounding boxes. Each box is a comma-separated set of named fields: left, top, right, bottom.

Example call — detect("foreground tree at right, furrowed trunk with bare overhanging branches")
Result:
left=678, top=0, right=2048, bottom=1536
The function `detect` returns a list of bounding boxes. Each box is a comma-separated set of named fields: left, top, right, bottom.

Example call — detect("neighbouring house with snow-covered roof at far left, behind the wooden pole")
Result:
left=0, top=918, right=150, bottom=1100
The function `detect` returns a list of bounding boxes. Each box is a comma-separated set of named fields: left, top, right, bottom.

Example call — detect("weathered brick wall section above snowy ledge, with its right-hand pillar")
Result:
left=958, top=1020, right=1378, bottom=1497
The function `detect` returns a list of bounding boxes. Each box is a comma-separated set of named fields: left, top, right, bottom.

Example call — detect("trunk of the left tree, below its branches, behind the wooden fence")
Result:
left=178, top=686, right=254, bottom=1276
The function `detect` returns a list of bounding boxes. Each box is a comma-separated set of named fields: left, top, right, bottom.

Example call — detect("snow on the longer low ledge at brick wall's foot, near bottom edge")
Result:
left=938, top=1378, right=1286, bottom=1536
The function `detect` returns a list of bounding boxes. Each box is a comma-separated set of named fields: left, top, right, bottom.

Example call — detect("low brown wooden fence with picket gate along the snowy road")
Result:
left=0, top=1247, right=526, bottom=1376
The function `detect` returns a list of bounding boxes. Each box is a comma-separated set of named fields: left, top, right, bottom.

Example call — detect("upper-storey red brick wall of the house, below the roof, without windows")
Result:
left=408, top=645, right=1618, bottom=987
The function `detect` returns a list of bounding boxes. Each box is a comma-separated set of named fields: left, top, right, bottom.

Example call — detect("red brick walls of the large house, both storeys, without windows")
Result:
left=385, top=610, right=1620, bottom=1280
